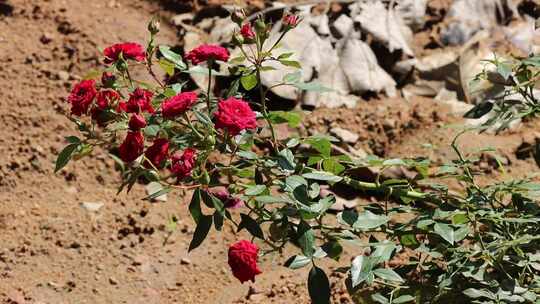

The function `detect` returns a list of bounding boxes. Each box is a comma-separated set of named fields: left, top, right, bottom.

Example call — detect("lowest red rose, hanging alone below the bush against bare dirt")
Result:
left=229, top=240, right=262, bottom=283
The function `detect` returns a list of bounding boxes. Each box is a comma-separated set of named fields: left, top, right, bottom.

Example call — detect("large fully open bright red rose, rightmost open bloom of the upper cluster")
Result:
left=215, top=97, right=257, bottom=136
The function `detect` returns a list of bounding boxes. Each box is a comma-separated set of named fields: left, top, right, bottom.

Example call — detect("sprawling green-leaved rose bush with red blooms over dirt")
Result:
left=55, top=12, right=540, bottom=303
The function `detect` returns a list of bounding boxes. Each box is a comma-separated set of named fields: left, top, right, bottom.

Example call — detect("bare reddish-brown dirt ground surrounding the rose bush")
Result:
left=0, top=0, right=539, bottom=304
